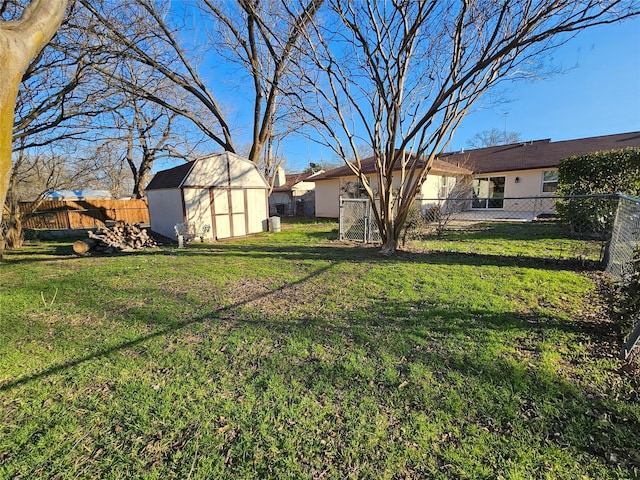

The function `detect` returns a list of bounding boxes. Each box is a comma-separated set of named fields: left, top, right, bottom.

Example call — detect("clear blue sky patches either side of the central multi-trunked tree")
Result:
left=283, top=13, right=640, bottom=171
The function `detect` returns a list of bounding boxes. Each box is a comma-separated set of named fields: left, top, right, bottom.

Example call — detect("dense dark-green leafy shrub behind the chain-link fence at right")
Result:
left=557, top=148, right=640, bottom=235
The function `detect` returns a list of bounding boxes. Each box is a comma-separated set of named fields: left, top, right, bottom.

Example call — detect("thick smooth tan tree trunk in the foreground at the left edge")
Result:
left=0, top=0, right=67, bottom=221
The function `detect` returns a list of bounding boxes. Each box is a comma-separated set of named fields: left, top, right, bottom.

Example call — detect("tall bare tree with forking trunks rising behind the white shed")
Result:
left=80, top=0, right=324, bottom=176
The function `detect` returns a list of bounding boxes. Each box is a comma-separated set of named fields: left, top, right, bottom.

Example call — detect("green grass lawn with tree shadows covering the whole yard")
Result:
left=0, top=222, right=640, bottom=479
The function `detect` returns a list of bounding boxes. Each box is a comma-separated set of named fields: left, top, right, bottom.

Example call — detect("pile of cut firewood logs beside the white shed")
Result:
left=73, top=221, right=157, bottom=253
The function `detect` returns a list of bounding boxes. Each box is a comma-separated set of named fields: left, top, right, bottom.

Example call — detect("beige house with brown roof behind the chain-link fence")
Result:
left=315, top=132, right=640, bottom=217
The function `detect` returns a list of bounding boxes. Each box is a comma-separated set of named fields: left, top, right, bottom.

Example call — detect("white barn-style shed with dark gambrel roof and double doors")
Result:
left=147, top=152, right=269, bottom=240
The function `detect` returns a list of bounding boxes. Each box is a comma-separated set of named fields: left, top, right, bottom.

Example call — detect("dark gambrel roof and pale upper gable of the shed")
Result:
left=147, top=152, right=269, bottom=190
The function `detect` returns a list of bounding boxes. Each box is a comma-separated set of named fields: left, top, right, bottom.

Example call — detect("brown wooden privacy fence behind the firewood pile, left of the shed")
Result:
left=20, top=200, right=149, bottom=230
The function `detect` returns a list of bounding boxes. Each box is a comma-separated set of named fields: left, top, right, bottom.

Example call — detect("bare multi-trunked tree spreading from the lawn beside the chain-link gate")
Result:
left=298, top=0, right=639, bottom=254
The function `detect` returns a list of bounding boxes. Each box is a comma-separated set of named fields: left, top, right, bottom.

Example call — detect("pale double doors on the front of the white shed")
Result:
left=211, top=188, right=249, bottom=239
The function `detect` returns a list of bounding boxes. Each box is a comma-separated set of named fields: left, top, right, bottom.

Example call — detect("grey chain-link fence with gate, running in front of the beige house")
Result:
left=340, top=194, right=640, bottom=358
